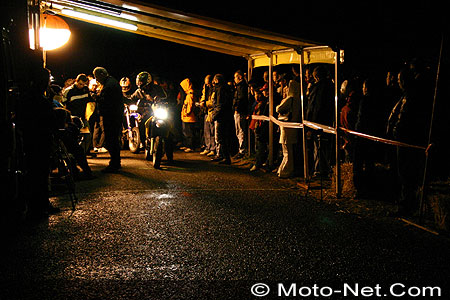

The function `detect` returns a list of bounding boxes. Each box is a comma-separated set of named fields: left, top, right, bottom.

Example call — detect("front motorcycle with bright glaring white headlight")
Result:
left=145, top=102, right=173, bottom=169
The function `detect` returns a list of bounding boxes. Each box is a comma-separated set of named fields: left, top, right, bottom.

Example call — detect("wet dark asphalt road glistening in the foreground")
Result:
left=0, top=151, right=450, bottom=299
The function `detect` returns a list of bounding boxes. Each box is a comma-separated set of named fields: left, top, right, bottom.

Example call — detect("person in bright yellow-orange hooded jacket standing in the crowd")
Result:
left=180, top=78, right=197, bottom=153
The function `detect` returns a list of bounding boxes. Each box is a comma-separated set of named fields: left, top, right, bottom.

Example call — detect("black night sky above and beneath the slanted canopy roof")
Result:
left=44, top=0, right=443, bottom=87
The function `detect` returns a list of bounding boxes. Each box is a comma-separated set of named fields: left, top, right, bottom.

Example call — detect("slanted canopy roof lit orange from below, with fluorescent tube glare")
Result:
left=41, top=0, right=334, bottom=65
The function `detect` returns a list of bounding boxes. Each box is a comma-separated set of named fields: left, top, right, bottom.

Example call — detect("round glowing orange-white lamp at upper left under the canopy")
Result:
left=29, top=14, right=70, bottom=51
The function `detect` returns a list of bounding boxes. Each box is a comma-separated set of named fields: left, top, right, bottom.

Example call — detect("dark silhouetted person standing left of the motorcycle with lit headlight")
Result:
left=93, top=67, right=123, bottom=173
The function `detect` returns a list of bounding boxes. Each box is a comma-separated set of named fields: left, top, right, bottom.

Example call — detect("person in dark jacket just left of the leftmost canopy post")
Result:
left=233, top=70, right=249, bottom=159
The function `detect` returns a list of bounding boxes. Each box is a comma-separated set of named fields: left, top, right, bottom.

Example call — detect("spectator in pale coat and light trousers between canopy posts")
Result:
left=276, top=80, right=301, bottom=178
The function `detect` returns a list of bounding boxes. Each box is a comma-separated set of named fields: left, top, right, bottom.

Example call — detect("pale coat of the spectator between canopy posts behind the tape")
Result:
left=276, top=80, right=301, bottom=144
